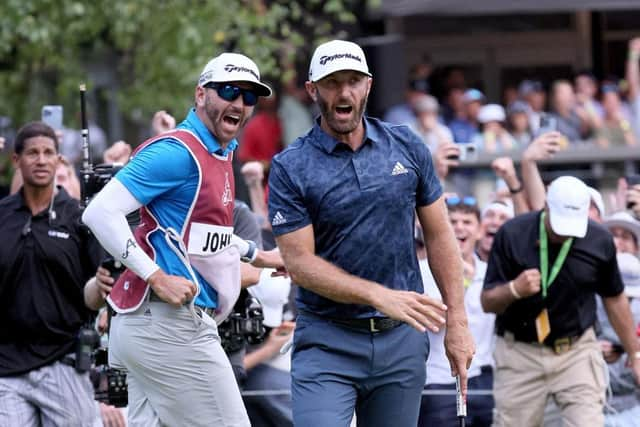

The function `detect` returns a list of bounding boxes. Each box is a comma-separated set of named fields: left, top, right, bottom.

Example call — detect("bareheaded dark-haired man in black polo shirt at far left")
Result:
left=0, top=122, right=103, bottom=426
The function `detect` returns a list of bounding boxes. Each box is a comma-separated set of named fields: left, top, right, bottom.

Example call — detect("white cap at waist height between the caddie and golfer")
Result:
left=247, top=268, right=291, bottom=328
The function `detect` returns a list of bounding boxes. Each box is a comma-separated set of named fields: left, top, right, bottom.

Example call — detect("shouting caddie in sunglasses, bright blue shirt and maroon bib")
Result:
left=83, top=53, right=271, bottom=426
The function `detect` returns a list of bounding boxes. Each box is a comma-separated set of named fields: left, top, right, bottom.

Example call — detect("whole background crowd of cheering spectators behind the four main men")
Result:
left=0, top=38, right=640, bottom=426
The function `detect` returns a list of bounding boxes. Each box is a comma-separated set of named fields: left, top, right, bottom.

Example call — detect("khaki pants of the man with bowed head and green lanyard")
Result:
left=493, top=328, right=606, bottom=427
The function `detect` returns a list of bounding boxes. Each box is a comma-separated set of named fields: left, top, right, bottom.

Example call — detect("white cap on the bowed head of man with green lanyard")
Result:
left=547, top=176, right=591, bottom=238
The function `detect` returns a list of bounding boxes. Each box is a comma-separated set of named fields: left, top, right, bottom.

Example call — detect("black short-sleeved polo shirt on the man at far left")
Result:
left=0, top=189, right=104, bottom=376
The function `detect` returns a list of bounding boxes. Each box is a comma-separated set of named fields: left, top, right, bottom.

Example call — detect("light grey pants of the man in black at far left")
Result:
left=0, top=362, right=102, bottom=427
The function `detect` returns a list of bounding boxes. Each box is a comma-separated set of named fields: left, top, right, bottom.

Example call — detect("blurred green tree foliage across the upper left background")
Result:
left=0, top=0, right=376, bottom=133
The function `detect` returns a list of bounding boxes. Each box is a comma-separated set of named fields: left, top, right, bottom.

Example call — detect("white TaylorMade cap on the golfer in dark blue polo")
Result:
left=309, top=40, right=371, bottom=82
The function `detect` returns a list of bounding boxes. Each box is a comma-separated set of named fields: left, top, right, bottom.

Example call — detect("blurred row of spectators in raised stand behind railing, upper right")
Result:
left=384, top=39, right=640, bottom=153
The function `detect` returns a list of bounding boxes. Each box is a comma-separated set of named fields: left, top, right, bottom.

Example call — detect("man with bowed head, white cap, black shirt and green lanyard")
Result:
left=481, top=176, right=640, bottom=426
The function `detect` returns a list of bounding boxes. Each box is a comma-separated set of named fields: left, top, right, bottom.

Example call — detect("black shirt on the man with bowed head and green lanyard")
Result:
left=484, top=212, right=624, bottom=344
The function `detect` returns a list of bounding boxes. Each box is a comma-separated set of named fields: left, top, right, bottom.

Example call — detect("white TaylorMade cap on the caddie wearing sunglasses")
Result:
left=198, top=52, right=271, bottom=96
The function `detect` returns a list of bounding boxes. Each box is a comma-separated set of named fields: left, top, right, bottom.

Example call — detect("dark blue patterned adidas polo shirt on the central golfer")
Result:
left=269, top=118, right=442, bottom=318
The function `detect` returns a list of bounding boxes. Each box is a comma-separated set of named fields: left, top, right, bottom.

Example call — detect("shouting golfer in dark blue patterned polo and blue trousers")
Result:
left=269, top=40, right=474, bottom=427
